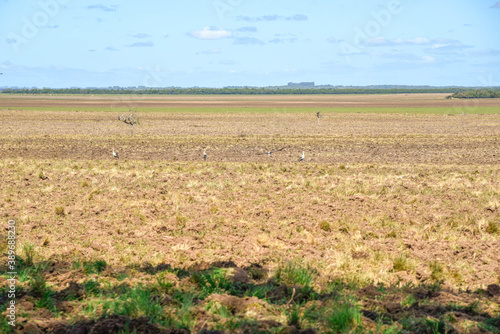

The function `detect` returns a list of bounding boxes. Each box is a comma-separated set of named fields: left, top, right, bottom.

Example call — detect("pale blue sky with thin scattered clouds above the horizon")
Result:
left=0, top=0, right=500, bottom=87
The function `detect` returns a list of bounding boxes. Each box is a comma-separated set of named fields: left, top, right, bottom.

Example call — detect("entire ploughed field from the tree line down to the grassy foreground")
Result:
left=0, top=94, right=500, bottom=333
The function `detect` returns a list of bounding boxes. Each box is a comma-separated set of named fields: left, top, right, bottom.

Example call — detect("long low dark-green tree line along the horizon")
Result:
left=1, top=87, right=478, bottom=97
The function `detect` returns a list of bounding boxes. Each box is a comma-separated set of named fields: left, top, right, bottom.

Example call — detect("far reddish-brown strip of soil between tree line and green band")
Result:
left=0, top=94, right=500, bottom=109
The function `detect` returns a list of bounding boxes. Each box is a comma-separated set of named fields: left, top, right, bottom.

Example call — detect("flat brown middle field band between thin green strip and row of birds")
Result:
left=0, top=110, right=500, bottom=165
